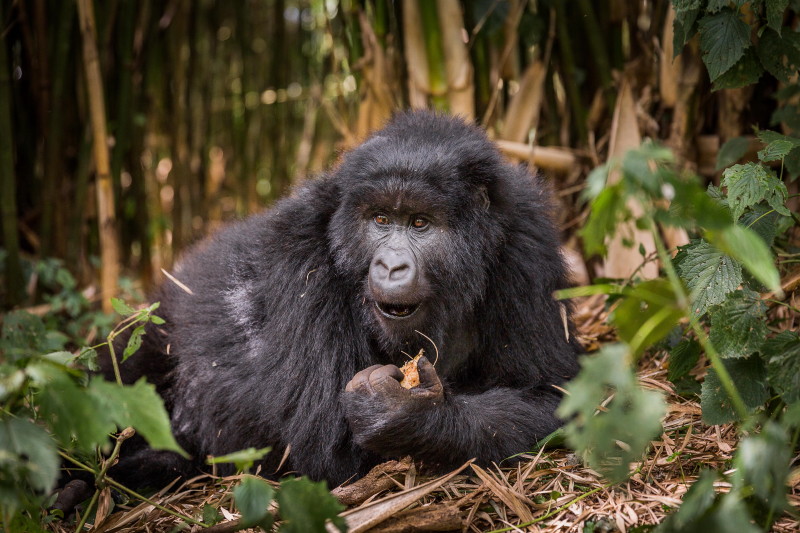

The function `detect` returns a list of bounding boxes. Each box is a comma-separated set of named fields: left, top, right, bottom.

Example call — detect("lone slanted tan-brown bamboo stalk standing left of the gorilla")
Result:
left=77, top=0, right=119, bottom=313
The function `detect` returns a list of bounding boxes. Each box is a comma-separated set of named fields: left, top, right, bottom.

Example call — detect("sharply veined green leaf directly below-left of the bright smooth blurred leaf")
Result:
left=675, top=240, right=742, bottom=317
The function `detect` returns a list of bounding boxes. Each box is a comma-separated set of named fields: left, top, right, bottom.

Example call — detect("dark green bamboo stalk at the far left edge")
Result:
left=0, top=29, right=25, bottom=307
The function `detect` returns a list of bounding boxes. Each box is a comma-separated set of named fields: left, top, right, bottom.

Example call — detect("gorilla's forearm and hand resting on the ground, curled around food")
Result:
left=344, top=357, right=561, bottom=468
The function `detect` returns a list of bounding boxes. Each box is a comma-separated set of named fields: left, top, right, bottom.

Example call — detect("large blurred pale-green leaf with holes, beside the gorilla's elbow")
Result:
left=557, top=344, right=665, bottom=481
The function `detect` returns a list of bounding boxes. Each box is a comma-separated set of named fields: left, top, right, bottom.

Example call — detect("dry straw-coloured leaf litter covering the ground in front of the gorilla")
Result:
left=45, top=298, right=800, bottom=533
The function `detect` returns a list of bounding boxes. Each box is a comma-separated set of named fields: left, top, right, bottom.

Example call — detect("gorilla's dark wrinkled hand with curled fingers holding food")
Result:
left=344, top=357, right=445, bottom=456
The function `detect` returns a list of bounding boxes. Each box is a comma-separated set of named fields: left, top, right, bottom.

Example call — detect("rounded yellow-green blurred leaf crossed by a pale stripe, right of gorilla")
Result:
left=610, top=279, right=684, bottom=356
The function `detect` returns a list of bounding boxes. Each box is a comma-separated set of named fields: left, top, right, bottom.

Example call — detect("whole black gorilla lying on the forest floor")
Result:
left=106, top=112, right=579, bottom=485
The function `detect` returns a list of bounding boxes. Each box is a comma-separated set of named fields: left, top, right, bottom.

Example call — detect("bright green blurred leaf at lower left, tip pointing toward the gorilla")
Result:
left=89, top=377, right=188, bottom=457
